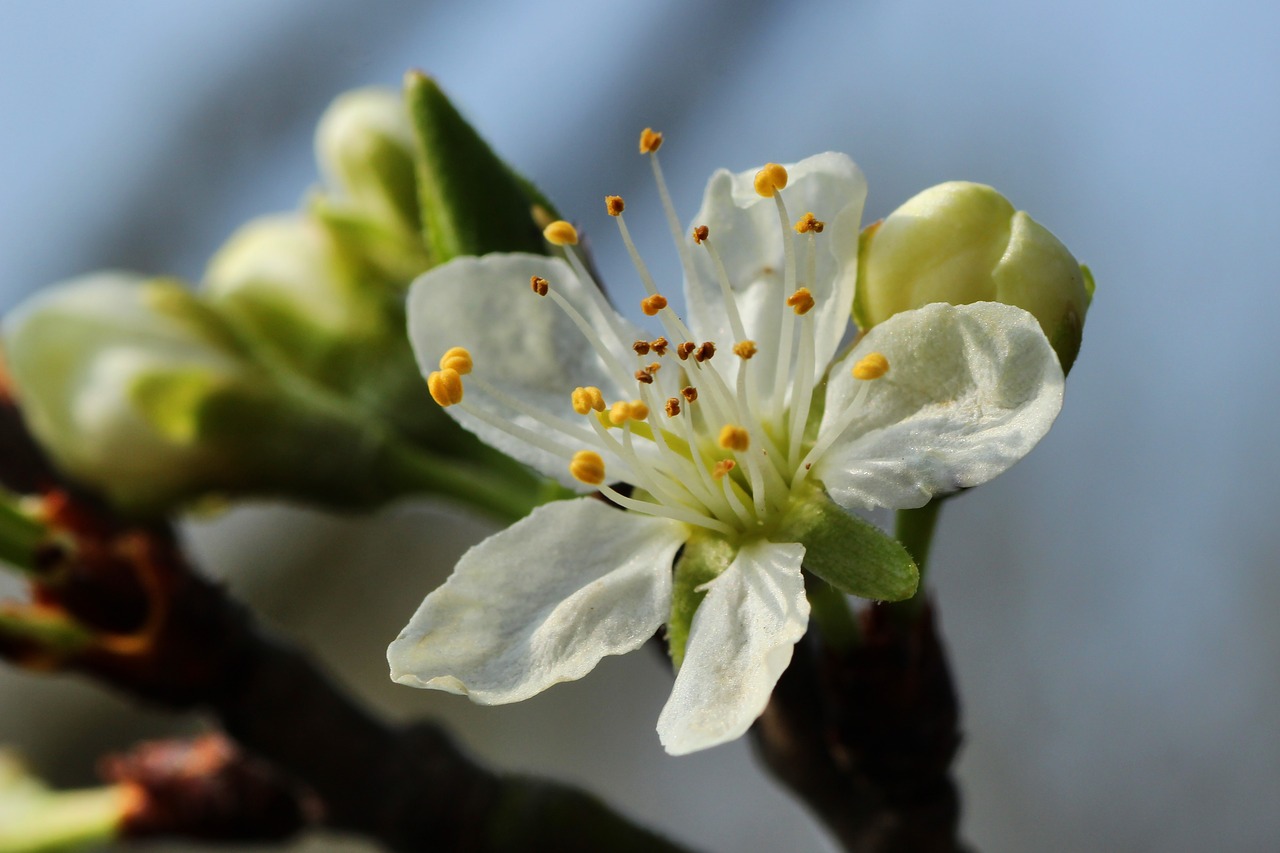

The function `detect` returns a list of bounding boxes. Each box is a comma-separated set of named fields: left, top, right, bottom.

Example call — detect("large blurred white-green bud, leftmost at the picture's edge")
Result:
left=4, top=273, right=265, bottom=507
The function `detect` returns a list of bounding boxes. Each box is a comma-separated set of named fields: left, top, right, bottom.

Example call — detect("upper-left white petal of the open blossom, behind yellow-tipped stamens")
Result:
left=408, top=254, right=646, bottom=489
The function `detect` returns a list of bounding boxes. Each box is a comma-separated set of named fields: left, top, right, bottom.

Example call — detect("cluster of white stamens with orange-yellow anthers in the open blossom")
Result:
left=428, top=128, right=888, bottom=535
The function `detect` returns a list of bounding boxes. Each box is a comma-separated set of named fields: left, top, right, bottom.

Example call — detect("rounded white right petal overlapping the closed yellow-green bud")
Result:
left=813, top=302, right=1062, bottom=508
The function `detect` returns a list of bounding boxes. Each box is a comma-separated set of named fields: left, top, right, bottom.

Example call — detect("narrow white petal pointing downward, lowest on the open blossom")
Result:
left=658, top=542, right=809, bottom=756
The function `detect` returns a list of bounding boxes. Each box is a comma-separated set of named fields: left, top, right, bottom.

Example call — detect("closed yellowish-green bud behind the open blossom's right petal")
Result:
left=854, top=181, right=1093, bottom=370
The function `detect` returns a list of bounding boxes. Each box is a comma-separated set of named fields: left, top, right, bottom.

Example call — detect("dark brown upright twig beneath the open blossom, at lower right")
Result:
left=751, top=596, right=964, bottom=853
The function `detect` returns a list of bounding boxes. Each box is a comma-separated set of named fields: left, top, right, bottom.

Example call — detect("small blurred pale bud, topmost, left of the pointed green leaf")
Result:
left=316, top=88, right=421, bottom=234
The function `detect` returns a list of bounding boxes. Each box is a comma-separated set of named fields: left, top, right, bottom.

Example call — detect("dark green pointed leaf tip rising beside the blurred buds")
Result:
left=404, top=72, right=547, bottom=264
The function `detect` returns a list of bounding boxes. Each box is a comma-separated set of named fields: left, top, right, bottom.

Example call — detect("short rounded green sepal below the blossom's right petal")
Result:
left=783, top=489, right=920, bottom=601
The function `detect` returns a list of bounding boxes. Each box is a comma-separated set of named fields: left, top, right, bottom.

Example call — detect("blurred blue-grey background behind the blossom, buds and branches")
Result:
left=0, top=0, right=1280, bottom=852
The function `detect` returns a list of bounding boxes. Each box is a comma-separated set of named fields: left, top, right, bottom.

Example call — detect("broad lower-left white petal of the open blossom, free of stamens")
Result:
left=387, top=498, right=689, bottom=704
